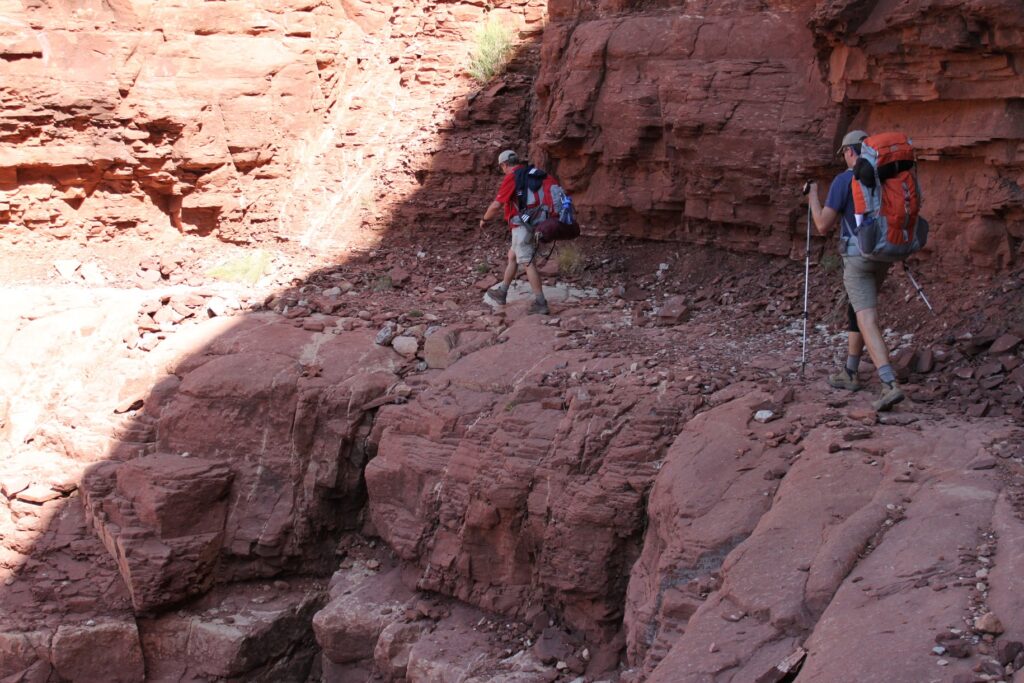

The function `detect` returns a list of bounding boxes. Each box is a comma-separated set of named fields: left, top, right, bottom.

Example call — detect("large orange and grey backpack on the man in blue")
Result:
left=852, top=132, right=928, bottom=261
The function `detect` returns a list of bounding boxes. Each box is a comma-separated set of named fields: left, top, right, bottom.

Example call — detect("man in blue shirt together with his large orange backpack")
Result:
left=804, top=130, right=928, bottom=411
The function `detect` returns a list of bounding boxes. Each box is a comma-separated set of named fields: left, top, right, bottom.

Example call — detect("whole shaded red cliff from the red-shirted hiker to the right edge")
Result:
left=534, top=0, right=1024, bottom=268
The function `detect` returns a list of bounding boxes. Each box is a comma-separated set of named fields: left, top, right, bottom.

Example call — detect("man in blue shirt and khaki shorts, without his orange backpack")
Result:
left=805, top=130, right=920, bottom=411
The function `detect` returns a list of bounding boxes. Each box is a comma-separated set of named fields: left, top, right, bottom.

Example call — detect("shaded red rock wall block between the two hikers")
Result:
left=534, top=3, right=840, bottom=255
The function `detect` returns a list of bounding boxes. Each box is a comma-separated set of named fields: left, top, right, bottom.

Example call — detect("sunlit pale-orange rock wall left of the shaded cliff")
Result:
left=0, top=0, right=545, bottom=248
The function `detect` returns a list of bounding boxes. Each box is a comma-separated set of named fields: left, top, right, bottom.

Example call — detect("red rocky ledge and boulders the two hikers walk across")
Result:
left=0, top=236, right=1024, bottom=681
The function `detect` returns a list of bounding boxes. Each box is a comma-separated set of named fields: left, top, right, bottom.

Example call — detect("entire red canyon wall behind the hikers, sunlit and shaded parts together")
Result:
left=0, top=0, right=1024, bottom=269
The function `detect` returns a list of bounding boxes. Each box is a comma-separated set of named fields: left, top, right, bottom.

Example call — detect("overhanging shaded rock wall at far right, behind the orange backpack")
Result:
left=810, top=1, right=1024, bottom=269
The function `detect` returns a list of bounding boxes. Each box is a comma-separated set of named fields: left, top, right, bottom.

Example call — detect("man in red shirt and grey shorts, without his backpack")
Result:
left=480, top=150, right=558, bottom=315
